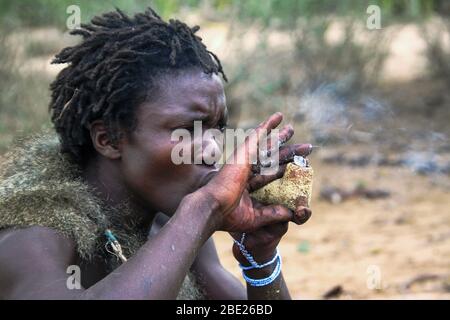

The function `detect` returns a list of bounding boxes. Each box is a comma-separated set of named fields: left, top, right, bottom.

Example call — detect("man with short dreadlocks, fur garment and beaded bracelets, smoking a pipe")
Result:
left=0, top=9, right=311, bottom=299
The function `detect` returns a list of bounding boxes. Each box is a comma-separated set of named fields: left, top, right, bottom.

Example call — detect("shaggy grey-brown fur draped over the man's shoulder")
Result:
left=0, top=133, right=105, bottom=259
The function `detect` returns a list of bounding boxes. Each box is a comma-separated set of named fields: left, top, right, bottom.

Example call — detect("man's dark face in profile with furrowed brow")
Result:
left=121, top=70, right=227, bottom=215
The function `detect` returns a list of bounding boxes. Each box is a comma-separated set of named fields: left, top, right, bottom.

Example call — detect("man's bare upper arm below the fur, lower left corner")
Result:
left=0, top=226, right=77, bottom=298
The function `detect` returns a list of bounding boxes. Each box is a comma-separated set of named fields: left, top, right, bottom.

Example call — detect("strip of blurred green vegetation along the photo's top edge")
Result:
left=0, top=0, right=448, bottom=27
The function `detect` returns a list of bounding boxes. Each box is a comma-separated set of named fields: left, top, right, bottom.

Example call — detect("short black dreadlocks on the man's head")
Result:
left=49, top=8, right=227, bottom=165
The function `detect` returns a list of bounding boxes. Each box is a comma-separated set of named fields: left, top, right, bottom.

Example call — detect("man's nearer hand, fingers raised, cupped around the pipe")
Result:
left=195, top=112, right=310, bottom=232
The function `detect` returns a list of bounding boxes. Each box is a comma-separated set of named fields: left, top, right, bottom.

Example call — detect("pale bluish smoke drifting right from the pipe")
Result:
left=297, top=82, right=450, bottom=185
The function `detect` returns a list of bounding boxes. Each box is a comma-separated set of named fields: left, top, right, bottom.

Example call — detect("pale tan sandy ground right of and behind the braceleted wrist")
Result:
left=215, top=160, right=450, bottom=299
